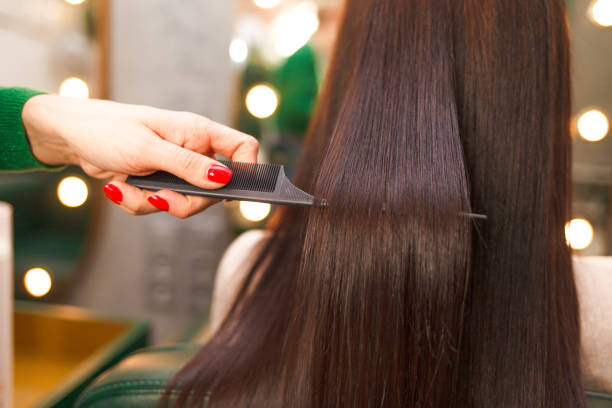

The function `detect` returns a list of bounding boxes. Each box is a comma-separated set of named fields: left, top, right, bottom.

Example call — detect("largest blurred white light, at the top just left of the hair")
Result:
left=272, top=1, right=319, bottom=57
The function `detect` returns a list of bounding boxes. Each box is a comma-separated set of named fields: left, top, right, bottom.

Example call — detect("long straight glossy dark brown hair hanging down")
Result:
left=166, top=0, right=585, bottom=408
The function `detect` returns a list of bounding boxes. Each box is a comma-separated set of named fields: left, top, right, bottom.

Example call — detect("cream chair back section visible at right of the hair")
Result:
left=574, top=257, right=612, bottom=393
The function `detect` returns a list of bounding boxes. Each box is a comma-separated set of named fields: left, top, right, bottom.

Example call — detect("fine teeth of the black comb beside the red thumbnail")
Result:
left=219, top=160, right=281, bottom=193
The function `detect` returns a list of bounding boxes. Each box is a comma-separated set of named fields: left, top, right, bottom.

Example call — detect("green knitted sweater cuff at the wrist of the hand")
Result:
left=0, top=88, right=64, bottom=170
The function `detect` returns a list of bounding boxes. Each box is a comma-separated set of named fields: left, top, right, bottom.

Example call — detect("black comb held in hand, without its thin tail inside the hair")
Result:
left=126, top=160, right=327, bottom=207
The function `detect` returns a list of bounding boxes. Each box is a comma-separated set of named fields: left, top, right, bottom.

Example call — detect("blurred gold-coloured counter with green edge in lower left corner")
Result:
left=14, top=302, right=149, bottom=408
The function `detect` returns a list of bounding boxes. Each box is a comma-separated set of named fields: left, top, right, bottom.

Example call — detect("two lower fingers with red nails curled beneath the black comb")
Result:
left=104, top=180, right=219, bottom=218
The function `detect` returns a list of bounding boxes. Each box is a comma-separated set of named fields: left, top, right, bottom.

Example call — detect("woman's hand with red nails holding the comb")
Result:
left=22, top=95, right=259, bottom=218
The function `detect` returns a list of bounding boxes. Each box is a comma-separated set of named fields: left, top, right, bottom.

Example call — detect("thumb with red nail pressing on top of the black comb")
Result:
left=148, top=139, right=232, bottom=189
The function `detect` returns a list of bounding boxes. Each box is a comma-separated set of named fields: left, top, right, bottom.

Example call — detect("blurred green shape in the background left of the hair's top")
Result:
left=274, top=44, right=319, bottom=136
